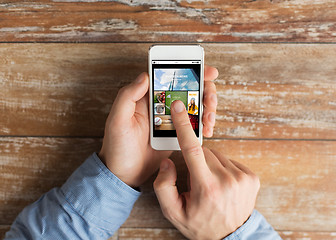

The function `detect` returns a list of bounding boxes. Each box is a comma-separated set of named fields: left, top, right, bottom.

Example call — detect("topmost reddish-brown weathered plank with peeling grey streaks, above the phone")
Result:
left=0, top=0, right=336, bottom=42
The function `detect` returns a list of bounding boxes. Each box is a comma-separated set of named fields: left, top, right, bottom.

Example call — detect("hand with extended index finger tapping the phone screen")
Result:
left=154, top=101, right=260, bottom=240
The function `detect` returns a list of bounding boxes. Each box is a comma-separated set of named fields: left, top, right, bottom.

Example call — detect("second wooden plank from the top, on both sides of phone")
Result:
left=0, top=44, right=336, bottom=139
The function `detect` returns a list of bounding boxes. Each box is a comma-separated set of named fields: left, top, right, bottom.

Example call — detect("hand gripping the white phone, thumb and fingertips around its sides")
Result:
left=98, top=66, right=218, bottom=187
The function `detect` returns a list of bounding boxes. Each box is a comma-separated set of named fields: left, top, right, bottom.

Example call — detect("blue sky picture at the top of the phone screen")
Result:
left=154, top=68, right=199, bottom=91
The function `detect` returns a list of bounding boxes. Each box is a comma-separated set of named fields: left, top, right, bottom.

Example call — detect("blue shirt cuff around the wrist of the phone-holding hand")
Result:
left=61, top=153, right=141, bottom=229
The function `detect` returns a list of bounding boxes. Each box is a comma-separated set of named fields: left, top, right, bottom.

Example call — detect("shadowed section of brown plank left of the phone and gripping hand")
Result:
left=0, top=44, right=146, bottom=136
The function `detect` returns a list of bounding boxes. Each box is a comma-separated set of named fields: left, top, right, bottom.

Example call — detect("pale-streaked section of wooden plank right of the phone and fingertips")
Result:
left=206, top=44, right=336, bottom=139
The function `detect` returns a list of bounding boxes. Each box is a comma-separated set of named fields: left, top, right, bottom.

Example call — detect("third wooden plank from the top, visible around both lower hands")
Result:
left=0, top=137, right=336, bottom=231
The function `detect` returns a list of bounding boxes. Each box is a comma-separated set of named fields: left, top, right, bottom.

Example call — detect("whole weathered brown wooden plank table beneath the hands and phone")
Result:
left=0, top=0, right=336, bottom=240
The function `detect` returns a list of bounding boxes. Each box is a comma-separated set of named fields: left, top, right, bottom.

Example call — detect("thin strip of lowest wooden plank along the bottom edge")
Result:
left=119, top=228, right=336, bottom=240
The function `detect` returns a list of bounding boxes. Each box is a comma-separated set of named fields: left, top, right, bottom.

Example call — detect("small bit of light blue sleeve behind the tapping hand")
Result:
left=223, top=210, right=281, bottom=240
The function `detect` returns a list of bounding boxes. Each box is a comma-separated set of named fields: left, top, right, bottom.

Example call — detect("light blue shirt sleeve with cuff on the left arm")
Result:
left=5, top=153, right=140, bottom=240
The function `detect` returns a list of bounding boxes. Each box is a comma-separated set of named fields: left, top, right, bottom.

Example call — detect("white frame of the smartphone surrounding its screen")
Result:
left=148, top=45, right=204, bottom=150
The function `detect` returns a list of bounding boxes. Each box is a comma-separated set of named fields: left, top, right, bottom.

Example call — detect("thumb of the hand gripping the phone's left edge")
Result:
left=111, top=73, right=149, bottom=124
